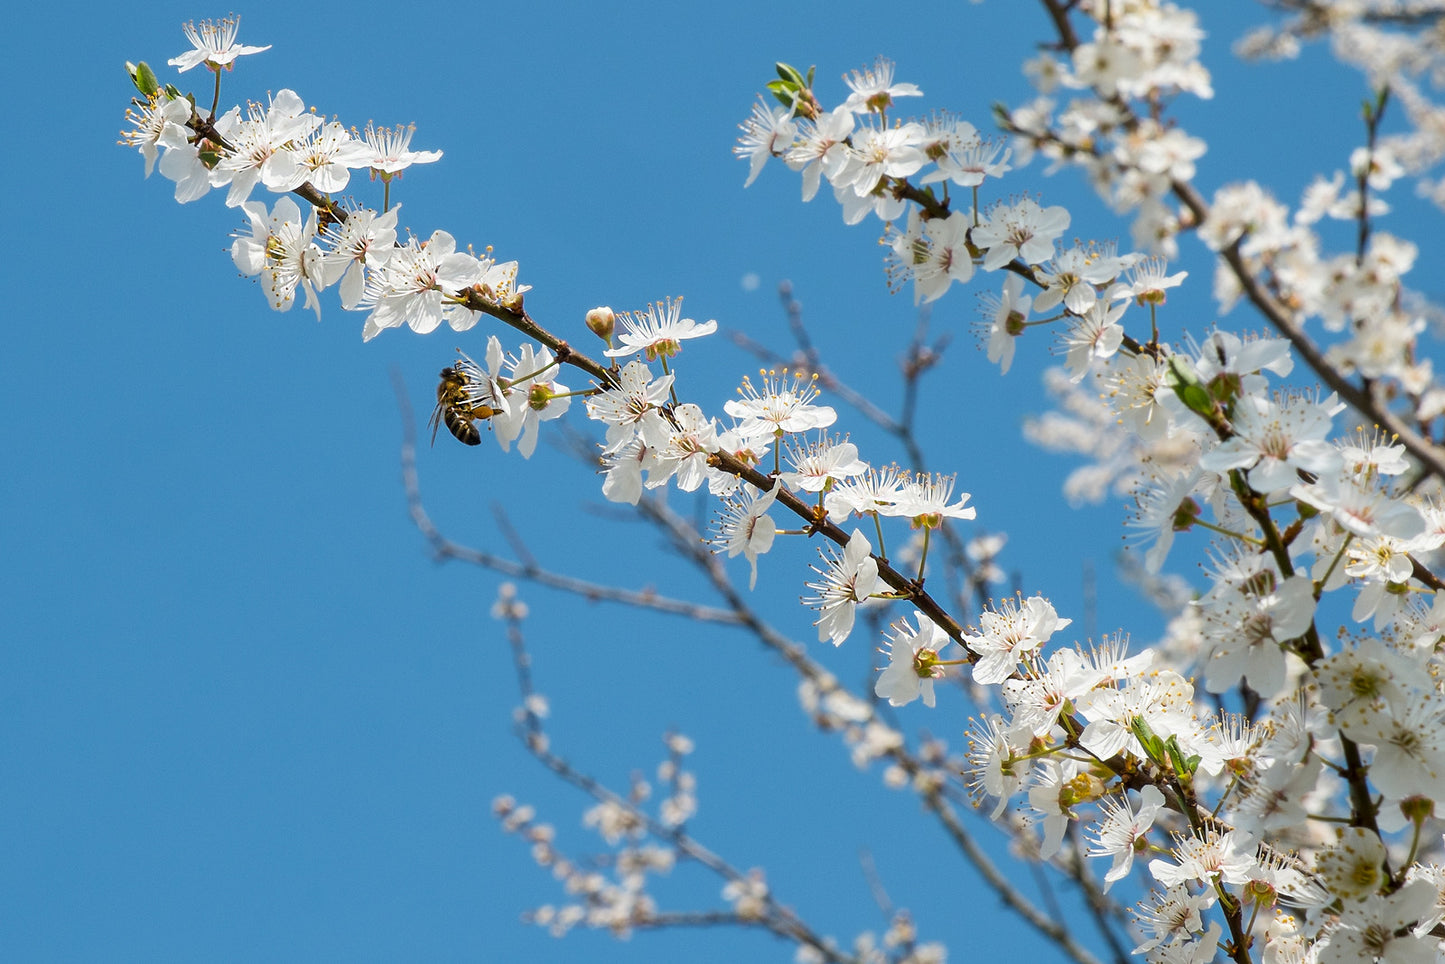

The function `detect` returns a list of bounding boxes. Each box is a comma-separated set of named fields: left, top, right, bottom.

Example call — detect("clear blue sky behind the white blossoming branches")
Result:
left=0, top=0, right=1398, bottom=961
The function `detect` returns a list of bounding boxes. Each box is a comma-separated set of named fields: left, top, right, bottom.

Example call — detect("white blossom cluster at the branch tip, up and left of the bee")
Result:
left=123, top=19, right=527, bottom=346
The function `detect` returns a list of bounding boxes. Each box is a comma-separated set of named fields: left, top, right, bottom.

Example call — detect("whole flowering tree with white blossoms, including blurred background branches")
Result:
left=115, top=7, right=1445, bottom=963
